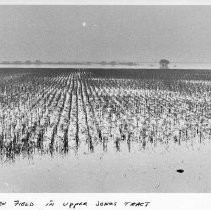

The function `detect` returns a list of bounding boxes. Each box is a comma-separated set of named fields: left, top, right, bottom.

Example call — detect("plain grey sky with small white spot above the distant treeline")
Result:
left=0, top=6, right=211, bottom=62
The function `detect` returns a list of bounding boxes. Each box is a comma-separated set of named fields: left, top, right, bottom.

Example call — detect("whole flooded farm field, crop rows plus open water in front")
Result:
left=0, top=69, right=211, bottom=192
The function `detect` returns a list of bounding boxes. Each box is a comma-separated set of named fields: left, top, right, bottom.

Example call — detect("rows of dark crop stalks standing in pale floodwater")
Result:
left=0, top=70, right=211, bottom=159
